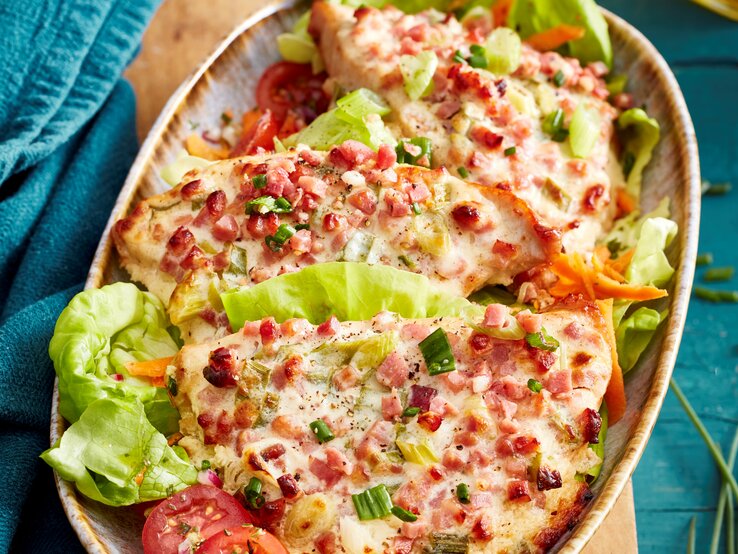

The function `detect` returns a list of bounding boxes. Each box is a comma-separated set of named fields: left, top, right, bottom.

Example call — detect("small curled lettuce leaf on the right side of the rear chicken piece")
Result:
left=618, top=108, right=661, bottom=200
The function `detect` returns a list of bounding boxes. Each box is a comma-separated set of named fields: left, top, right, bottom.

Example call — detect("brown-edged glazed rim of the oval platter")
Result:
left=50, top=0, right=701, bottom=554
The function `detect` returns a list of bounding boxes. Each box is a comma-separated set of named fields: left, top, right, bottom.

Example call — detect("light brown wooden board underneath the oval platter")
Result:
left=126, top=0, right=638, bottom=554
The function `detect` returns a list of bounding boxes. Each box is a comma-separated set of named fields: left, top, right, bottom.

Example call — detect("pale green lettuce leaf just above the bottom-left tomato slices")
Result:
left=41, top=397, right=197, bottom=506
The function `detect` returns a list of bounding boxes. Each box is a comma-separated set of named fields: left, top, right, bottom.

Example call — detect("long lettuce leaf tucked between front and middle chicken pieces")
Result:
left=221, top=262, right=481, bottom=331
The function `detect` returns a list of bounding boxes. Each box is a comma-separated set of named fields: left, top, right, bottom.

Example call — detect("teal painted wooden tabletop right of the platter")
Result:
left=600, top=0, right=738, bottom=553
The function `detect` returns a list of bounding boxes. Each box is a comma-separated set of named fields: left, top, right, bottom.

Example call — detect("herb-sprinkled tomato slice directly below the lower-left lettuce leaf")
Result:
left=142, top=485, right=251, bottom=554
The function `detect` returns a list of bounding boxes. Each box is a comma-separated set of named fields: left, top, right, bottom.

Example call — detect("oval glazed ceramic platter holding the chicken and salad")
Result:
left=51, top=0, right=700, bottom=553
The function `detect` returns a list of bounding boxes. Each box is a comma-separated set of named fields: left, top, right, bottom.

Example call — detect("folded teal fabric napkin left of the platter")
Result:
left=0, top=0, right=158, bottom=552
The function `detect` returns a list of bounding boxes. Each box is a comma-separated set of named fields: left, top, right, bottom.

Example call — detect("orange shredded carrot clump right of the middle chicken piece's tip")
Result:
left=549, top=253, right=668, bottom=301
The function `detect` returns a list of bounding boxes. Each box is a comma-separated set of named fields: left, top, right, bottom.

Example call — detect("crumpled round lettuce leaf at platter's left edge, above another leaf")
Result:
left=49, top=283, right=179, bottom=434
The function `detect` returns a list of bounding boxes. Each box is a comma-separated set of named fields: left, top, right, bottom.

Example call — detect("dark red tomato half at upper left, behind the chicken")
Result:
left=256, top=62, right=330, bottom=123
